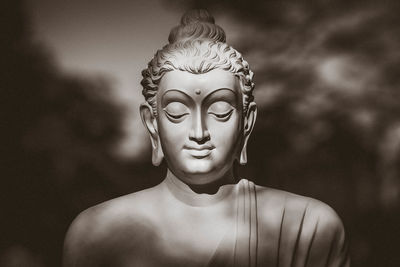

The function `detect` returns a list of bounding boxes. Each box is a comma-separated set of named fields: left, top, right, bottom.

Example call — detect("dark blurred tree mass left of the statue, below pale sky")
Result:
left=0, top=0, right=152, bottom=266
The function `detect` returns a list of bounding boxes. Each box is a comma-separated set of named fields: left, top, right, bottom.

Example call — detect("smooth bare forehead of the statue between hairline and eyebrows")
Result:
left=158, top=69, right=240, bottom=96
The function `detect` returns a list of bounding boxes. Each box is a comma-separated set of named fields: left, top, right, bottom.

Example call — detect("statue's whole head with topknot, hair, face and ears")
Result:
left=140, top=10, right=257, bottom=184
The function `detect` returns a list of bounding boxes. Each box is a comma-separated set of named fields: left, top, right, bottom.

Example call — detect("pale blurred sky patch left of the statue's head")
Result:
left=28, top=0, right=187, bottom=158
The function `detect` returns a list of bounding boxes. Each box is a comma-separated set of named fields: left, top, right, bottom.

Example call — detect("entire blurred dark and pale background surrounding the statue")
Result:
left=0, top=0, right=400, bottom=267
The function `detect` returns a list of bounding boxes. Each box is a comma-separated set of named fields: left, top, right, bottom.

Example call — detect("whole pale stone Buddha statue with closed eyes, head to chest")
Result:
left=64, top=10, right=349, bottom=267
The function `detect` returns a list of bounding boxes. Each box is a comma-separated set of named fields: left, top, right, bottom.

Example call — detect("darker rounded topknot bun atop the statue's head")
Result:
left=168, top=9, right=226, bottom=44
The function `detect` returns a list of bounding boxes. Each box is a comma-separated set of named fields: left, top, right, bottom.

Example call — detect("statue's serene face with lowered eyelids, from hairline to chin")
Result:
left=157, top=69, right=243, bottom=184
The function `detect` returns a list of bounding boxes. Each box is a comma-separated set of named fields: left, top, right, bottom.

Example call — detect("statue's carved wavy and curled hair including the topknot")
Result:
left=141, top=10, right=254, bottom=116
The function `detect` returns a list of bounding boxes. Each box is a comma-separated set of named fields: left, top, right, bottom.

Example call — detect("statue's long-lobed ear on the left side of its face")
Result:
left=140, top=102, right=164, bottom=166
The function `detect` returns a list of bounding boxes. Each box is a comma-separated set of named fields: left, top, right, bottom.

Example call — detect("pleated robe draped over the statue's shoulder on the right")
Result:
left=206, top=179, right=350, bottom=267
